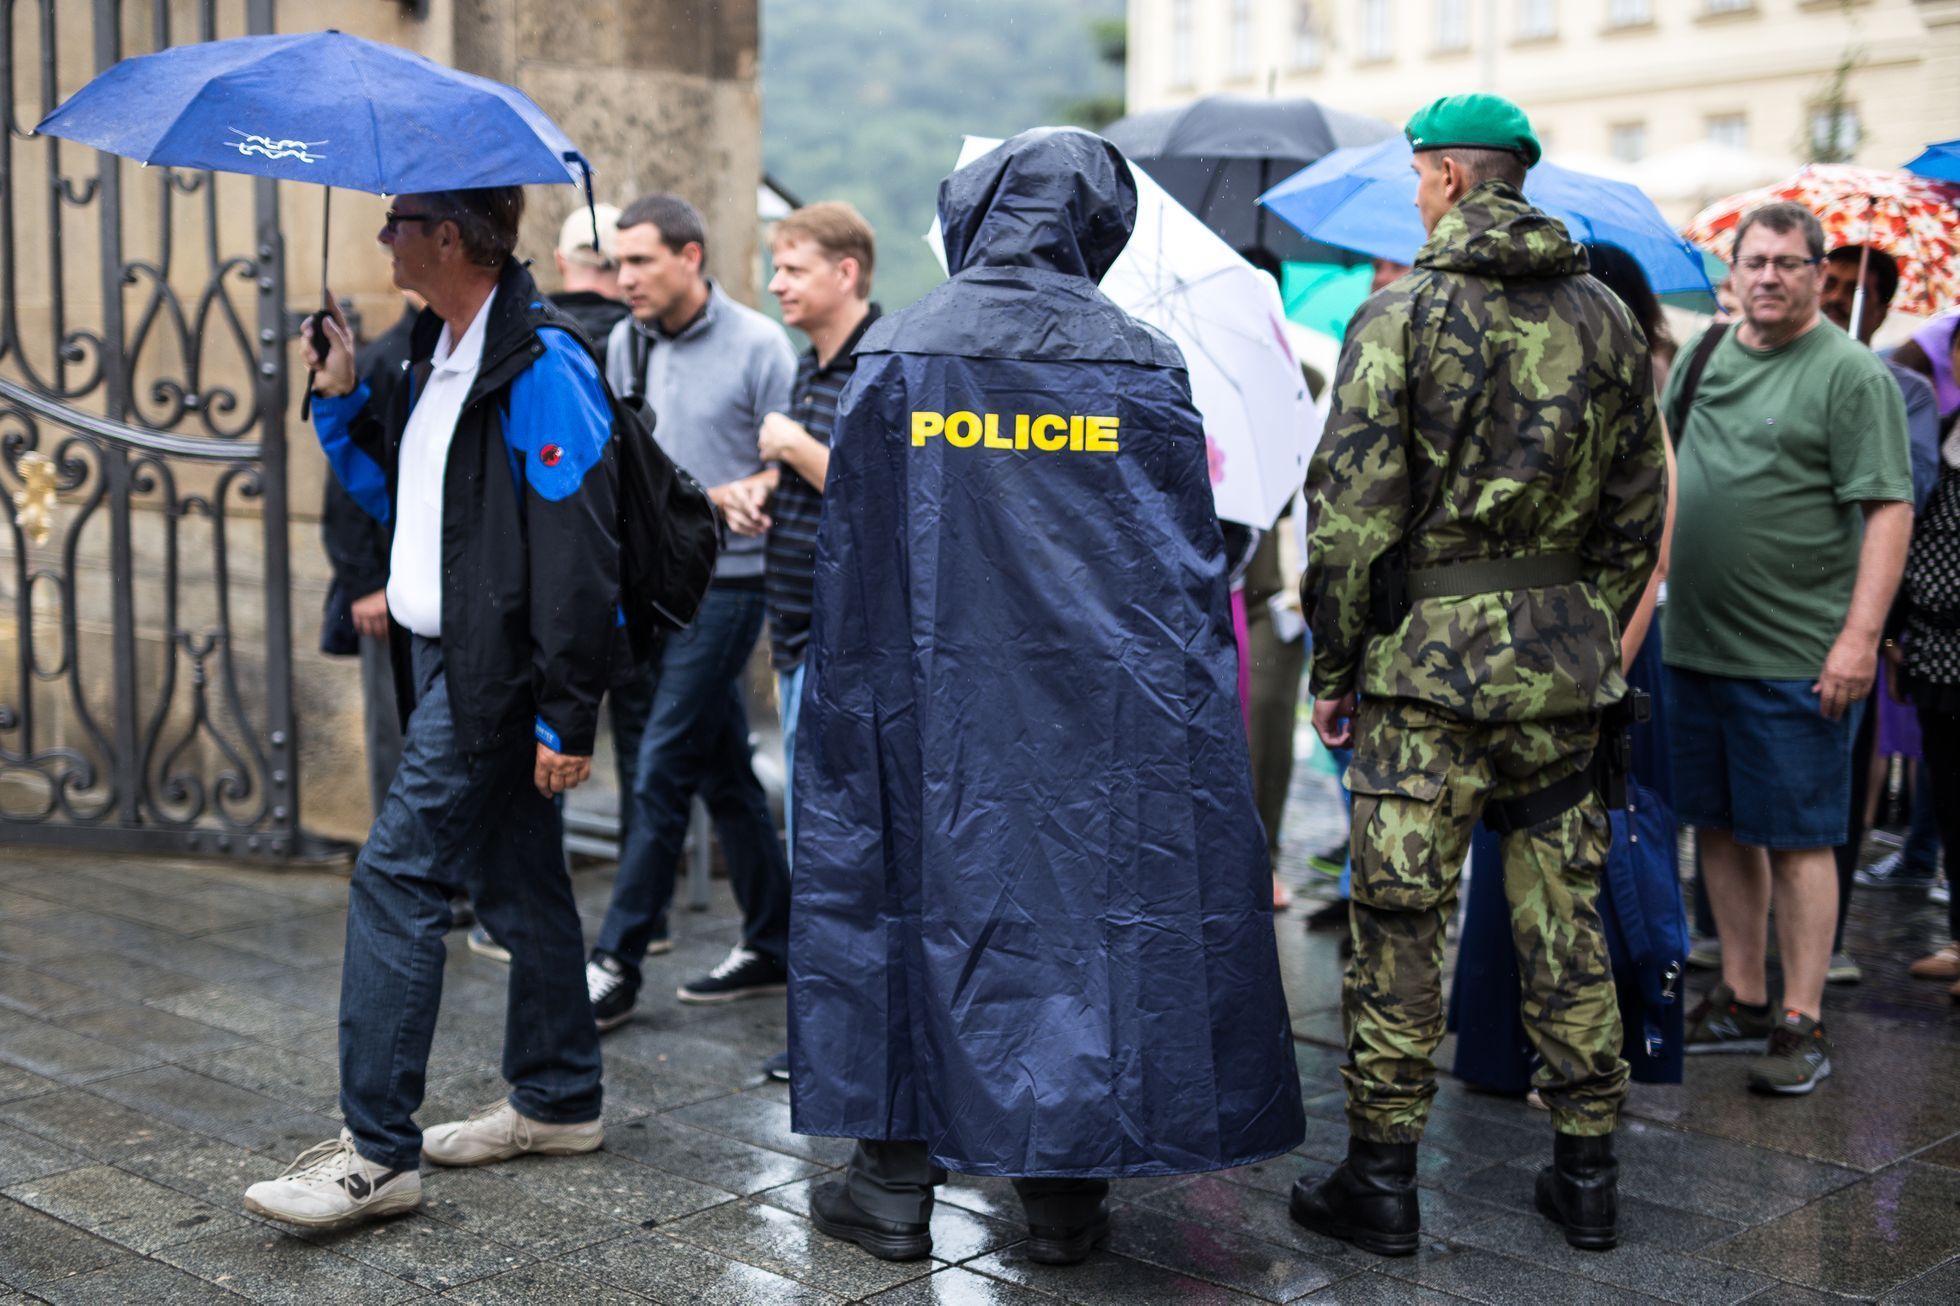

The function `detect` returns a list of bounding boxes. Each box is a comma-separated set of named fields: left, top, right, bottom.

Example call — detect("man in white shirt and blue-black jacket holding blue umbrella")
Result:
left=245, top=186, right=625, bottom=1230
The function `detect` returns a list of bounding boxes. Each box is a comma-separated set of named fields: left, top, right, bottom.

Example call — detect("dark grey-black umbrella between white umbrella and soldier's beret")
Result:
left=1103, top=96, right=1396, bottom=263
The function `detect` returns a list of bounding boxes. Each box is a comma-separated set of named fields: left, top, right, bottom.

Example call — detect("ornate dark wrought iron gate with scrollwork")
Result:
left=0, top=0, right=325, bottom=859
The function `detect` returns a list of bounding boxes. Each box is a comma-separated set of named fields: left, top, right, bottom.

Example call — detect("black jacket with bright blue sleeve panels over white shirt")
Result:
left=314, top=261, right=627, bottom=755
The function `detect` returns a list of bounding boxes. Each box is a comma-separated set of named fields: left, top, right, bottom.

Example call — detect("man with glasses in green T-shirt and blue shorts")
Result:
left=1662, top=204, right=1913, bottom=1094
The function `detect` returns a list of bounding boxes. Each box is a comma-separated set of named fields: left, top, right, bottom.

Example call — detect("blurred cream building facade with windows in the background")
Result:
left=1129, top=0, right=1960, bottom=218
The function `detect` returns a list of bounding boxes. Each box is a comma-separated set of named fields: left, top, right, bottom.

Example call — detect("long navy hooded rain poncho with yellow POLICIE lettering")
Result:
left=790, top=129, right=1303, bottom=1177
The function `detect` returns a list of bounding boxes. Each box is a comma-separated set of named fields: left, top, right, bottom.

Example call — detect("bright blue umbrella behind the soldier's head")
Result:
left=1258, top=135, right=1715, bottom=298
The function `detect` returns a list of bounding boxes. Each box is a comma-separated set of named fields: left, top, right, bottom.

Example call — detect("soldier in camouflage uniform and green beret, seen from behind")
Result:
left=1292, top=94, right=1666, bottom=1255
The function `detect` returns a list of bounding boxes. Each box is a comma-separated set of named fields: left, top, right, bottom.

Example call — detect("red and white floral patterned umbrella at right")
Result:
left=1682, top=163, right=1960, bottom=316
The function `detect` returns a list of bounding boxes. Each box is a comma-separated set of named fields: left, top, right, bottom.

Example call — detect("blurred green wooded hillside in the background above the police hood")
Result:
left=762, top=0, right=1123, bottom=308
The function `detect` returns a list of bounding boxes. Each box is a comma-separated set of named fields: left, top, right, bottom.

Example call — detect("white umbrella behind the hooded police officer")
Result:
left=925, top=135, right=1321, bottom=529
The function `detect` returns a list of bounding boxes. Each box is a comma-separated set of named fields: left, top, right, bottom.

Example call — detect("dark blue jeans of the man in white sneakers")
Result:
left=341, top=637, right=600, bottom=1169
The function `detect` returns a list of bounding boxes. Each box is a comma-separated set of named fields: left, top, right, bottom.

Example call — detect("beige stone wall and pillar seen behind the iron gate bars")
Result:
left=0, top=0, right=760, bottom=839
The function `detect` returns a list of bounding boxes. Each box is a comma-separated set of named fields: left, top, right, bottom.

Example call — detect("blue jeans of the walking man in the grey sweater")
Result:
left=595, top=584, right=790, bottom=980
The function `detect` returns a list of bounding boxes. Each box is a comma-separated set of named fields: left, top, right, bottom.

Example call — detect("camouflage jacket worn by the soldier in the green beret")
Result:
left=1301, top=182, right=1666, bottom=720
